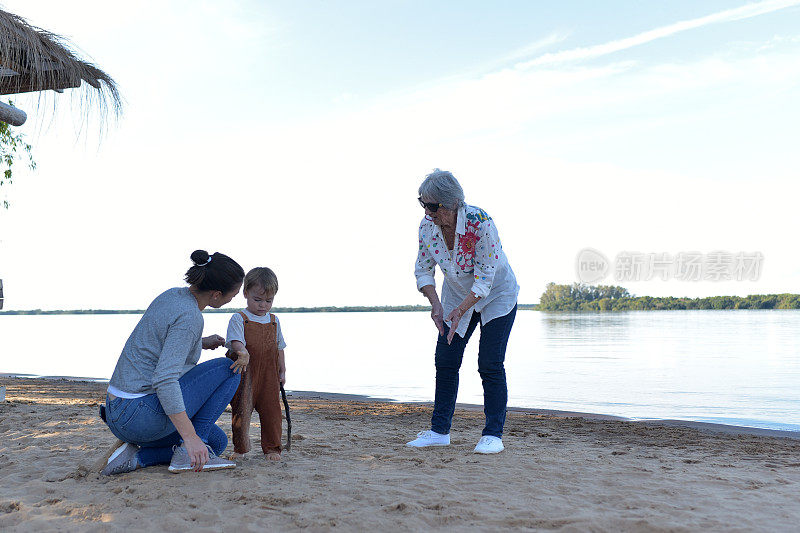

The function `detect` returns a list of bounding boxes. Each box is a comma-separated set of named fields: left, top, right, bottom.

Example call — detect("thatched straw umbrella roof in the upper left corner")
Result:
left=0, top=10, right=122, bottom=122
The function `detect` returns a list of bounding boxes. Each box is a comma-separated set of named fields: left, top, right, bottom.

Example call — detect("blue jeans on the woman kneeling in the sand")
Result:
left=106, top=357, right=241, bottom=466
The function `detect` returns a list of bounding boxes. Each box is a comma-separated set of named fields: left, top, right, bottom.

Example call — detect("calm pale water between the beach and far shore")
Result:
left=0, top=311, right=800, bottom=431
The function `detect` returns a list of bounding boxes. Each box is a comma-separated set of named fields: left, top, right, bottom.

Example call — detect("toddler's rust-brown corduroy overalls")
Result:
left=228, top=313, right=283, bottom=453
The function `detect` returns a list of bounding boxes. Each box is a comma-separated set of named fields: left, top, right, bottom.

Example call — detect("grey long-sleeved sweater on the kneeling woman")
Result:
left=109, top=287, right=203, bottom=415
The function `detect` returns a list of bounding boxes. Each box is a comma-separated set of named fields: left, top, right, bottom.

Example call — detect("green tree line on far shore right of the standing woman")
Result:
left=537, top=283, right=800, bottom=311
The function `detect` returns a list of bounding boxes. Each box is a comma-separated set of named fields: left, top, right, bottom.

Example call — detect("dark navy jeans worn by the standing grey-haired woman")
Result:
left=431, top=305, right=517, bottom=437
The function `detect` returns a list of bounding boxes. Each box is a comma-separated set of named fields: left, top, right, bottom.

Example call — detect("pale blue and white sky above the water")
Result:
left=0, top=0, right=800, bottom=309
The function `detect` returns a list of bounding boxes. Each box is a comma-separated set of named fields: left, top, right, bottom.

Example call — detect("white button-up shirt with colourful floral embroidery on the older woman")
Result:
left=414, top=205, right=519, bottom=337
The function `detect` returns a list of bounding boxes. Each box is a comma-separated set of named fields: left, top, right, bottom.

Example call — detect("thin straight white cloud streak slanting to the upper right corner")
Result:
left=517, top=0, right=800, bottom=69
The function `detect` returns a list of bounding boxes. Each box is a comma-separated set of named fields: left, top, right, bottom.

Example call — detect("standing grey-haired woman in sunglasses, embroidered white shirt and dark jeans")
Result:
left=408, top=169, right=519, bottom=453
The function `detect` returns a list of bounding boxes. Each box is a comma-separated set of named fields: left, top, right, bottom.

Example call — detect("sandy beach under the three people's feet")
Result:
left=0, top=378, right=800, bottom=531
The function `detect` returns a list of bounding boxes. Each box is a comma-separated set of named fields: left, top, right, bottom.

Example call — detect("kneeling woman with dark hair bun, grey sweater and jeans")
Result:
left=102, top=250, right=244, bottom=475
